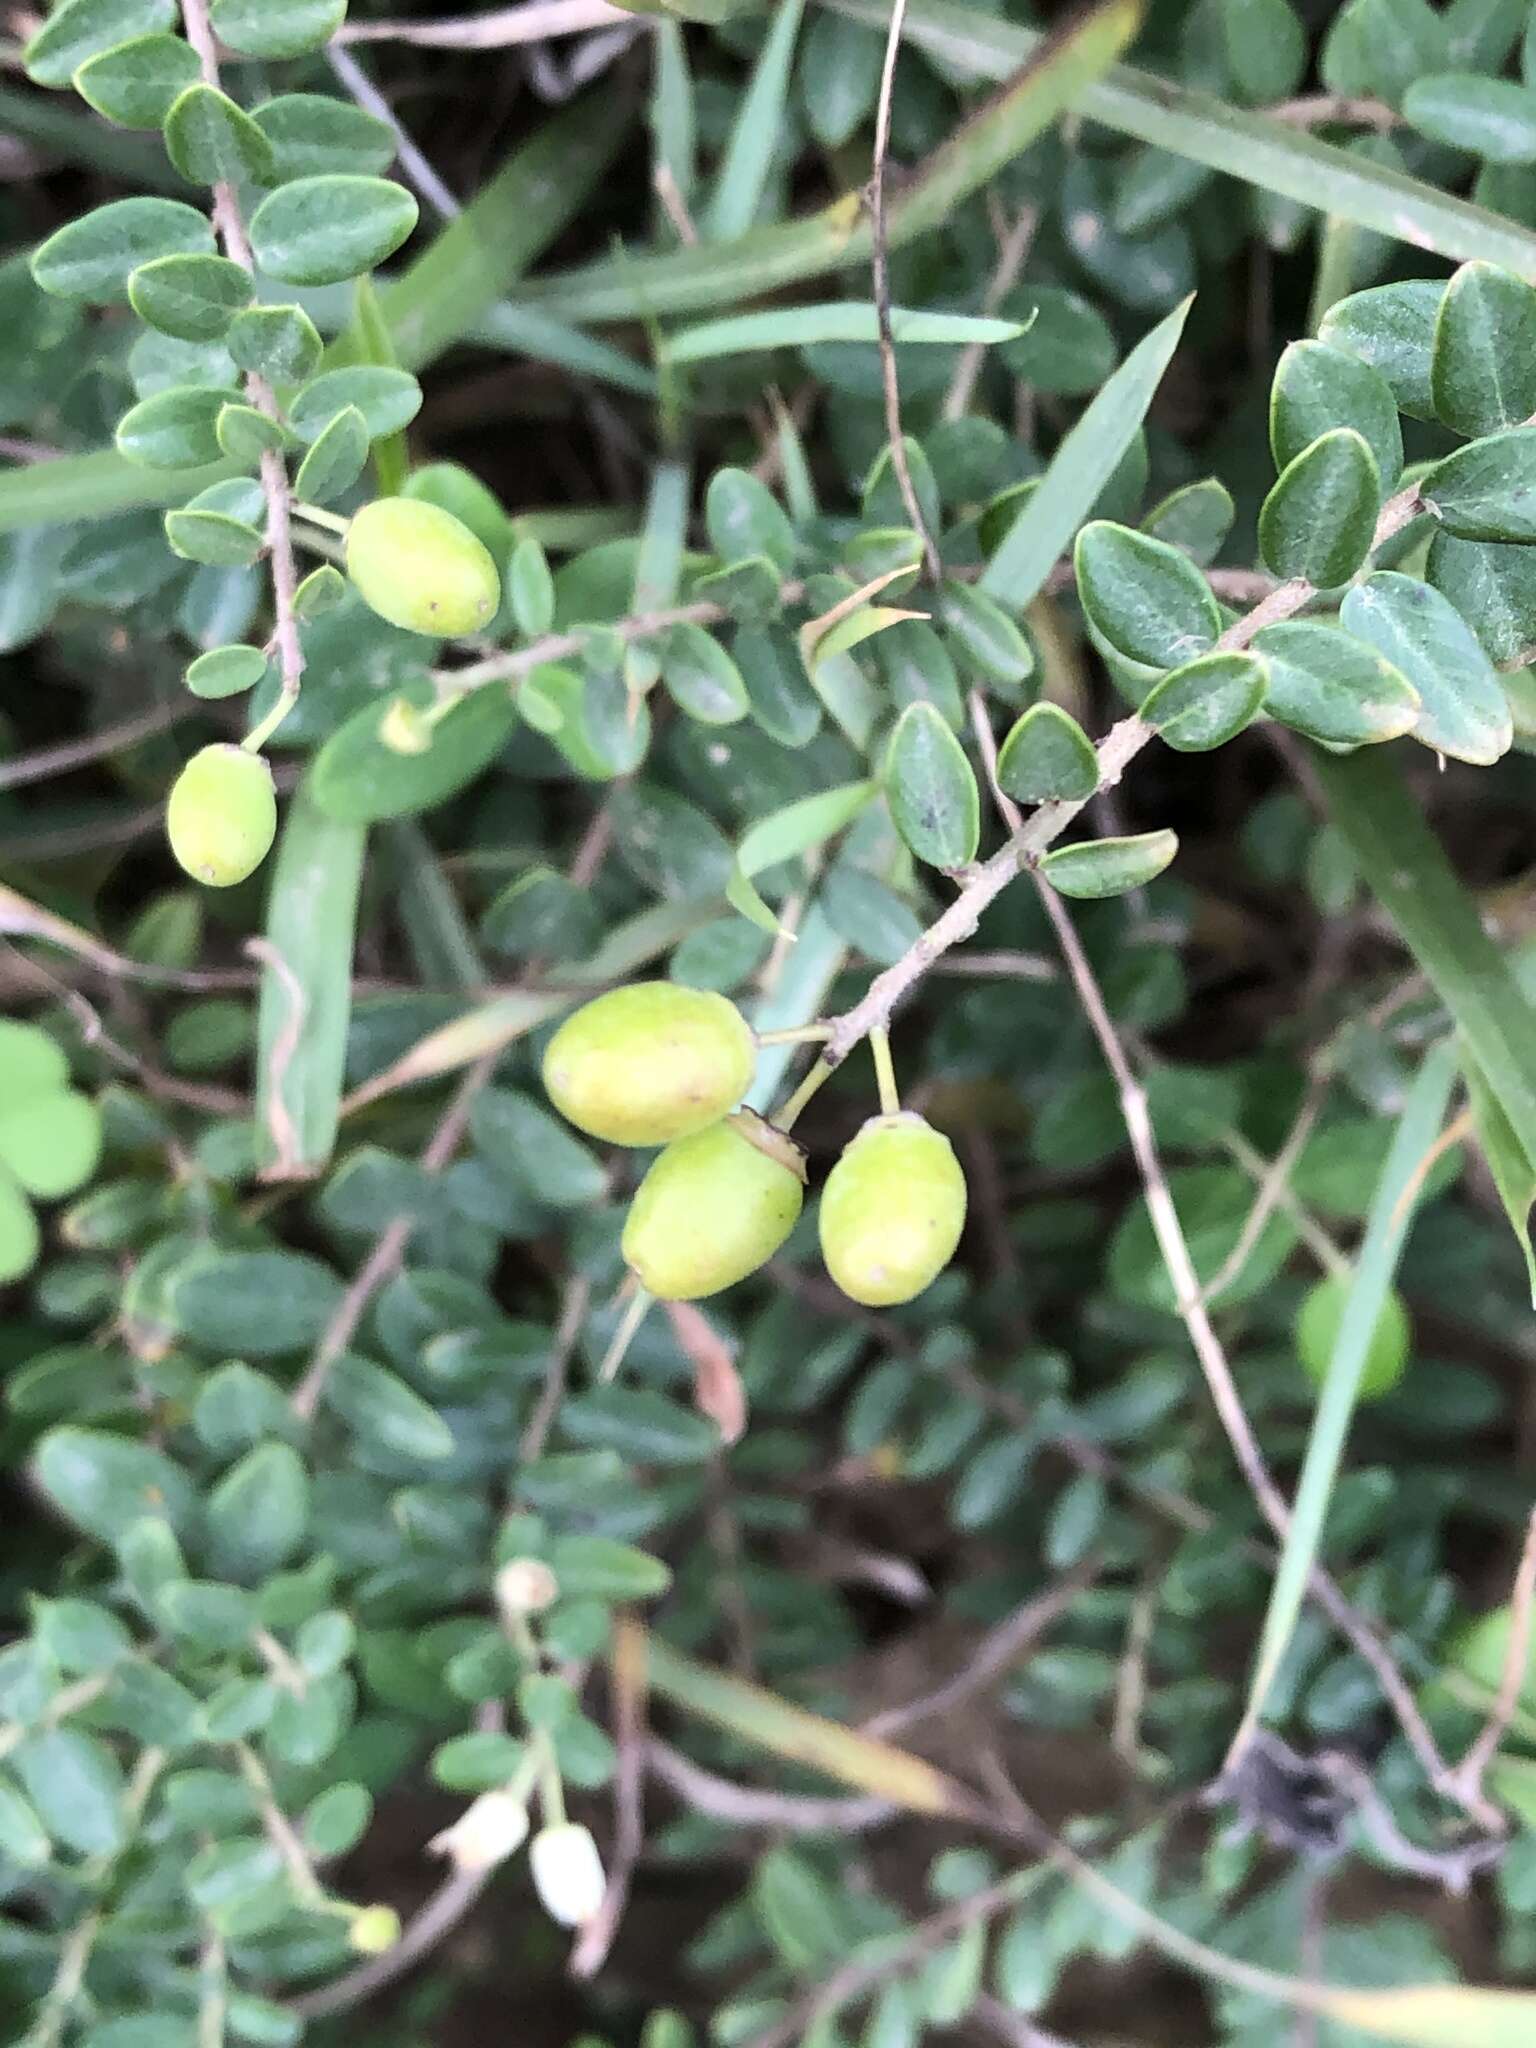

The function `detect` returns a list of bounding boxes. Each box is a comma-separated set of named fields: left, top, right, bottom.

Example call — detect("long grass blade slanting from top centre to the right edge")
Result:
left=827, top=0, right=1536, bottom=276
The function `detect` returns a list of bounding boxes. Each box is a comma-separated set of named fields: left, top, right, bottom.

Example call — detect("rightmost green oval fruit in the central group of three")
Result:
left=821, top=1110, right=965, bottom=1309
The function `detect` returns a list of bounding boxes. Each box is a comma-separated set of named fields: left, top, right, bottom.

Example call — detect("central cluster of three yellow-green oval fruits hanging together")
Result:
left=545, top=981, right=965, bottom=1309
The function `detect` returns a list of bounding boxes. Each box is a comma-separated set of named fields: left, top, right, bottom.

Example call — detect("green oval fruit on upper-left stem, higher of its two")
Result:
left=346, top=498, right=502, bottom=639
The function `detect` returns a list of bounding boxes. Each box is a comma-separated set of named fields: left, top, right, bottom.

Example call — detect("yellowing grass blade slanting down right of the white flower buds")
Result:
left=625, top=1622, right=965, bottom=1812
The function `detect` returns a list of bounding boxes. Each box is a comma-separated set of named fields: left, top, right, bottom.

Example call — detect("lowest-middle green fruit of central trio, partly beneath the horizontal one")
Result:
left=625, top=1110, right=805, bottom=1300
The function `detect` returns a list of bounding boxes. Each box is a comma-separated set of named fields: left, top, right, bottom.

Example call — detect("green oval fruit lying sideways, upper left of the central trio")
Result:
left=545, top=981, right=758, bottom=1145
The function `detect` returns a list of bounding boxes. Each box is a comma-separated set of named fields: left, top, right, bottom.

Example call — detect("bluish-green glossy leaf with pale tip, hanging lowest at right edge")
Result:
left=1339, top=569, right=1513, bottom=766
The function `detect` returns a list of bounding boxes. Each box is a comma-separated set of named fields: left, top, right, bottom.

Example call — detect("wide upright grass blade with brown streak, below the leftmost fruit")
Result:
left=256, top=782, right=367, bottom=1180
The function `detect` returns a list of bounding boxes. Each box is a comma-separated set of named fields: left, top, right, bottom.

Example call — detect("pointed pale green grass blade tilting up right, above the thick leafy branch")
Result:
left=981, top=299, right=1192, bottom=612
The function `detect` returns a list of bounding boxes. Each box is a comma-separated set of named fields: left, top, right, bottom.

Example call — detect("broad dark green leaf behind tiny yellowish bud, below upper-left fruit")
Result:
left=311, top=684, right=518, bottom=825
